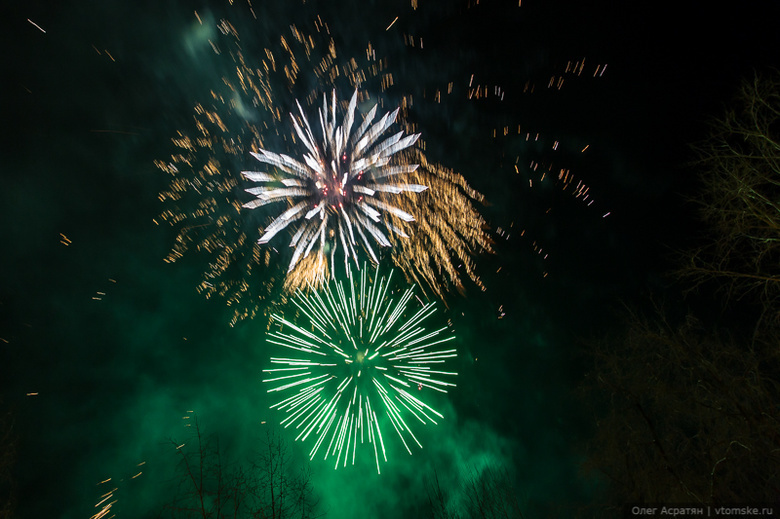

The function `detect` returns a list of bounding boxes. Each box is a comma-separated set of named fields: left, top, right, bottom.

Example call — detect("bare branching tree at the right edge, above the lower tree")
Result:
left=680, top=72, right=780, bottom=328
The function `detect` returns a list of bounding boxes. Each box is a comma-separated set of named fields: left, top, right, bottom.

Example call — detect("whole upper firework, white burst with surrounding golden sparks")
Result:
left=155, top=20, right=491, bottom=324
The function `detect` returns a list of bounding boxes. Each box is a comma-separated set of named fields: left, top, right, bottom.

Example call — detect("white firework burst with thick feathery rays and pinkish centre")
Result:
left=241, top=90, right=428, bottom=272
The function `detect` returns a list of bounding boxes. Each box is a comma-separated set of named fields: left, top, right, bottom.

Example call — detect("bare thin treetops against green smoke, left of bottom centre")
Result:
left=165, top=419, right=318, bottom=519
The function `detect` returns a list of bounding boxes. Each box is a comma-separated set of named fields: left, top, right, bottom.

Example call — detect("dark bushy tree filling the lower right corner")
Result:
left=586, top=308, right=780, bottom=507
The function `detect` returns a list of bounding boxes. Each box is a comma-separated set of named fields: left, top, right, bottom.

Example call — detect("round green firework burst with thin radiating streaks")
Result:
left=263, top=266, right=457, bottom=472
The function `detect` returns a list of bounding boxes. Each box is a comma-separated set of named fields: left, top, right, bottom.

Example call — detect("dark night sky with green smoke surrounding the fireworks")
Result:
left=0, top=0, right=780, bottom=519
